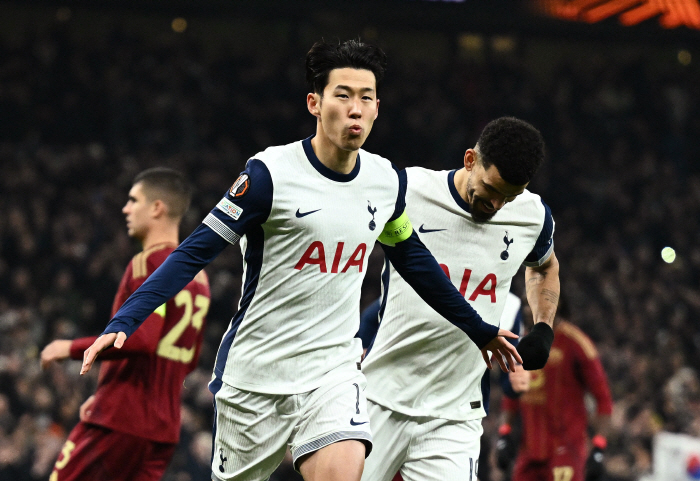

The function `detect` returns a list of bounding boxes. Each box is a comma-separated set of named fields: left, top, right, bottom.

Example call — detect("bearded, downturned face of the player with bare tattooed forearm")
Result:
left=465, top=153, right=527, bottom=222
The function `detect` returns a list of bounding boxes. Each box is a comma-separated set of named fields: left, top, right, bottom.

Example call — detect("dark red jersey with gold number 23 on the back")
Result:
left=71, top=244, right=210, bottom=443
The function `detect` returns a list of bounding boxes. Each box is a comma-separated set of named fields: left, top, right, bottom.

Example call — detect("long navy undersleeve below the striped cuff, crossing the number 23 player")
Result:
left=102, top=224, right=228, bottom=337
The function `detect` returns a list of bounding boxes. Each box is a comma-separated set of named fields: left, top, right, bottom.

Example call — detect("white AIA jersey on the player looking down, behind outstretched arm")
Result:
left=363, top=168, right=554, bottom=421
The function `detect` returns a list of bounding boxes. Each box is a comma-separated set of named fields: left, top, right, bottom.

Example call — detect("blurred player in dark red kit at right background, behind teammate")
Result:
left=497, top=304, right=612, bottom=481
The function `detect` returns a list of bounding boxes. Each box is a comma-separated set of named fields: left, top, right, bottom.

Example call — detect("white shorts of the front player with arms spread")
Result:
left=211, top=371, right=372, bottom=481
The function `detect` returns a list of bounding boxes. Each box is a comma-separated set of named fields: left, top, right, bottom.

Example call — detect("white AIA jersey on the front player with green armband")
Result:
left=204, top=139, right=402, bottom=394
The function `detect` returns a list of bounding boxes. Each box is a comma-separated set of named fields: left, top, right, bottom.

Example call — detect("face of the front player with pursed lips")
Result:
left=309, top=68, right=379, bottom=151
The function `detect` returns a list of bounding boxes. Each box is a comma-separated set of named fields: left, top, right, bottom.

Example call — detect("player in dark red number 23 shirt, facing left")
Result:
left=41, top=168, right=210, bottom=481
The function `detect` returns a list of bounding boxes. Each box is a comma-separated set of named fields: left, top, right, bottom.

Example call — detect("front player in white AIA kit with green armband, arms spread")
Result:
left=82, top=40, right=520, bottom=481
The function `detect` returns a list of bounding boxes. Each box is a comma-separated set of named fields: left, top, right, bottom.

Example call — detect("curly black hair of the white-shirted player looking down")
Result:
left=477, top=117, right=544, bottom=185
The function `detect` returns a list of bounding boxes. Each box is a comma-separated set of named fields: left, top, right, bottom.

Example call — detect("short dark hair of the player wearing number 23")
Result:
left=133, top=167, right=192, bottom=219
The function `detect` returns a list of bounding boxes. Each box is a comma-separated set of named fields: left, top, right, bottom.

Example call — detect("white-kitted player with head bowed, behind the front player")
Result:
left=362, top=117, right=559, bottom=481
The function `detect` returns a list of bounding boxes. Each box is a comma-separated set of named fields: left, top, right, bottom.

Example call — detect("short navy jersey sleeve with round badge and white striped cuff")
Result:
left=202, top=159, right=272, bottom=240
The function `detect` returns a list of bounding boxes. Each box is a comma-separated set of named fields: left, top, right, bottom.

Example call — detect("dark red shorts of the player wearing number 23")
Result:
left=49, top=422, right=177, bottom=481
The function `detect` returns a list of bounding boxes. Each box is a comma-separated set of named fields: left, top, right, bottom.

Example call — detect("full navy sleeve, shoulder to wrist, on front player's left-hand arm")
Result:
left=103, top=159, right=272, bottom=336
